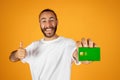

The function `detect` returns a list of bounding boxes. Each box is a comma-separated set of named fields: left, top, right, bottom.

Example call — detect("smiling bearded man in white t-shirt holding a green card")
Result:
left=10, top=9, right=95, bottom=80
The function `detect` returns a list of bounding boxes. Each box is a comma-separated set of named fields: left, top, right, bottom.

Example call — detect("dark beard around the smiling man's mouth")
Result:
left=41, top=25, right=57, bottom=38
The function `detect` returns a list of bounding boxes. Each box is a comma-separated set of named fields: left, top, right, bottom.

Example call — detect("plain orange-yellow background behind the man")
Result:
left=0, top=0, right=120, bottom=80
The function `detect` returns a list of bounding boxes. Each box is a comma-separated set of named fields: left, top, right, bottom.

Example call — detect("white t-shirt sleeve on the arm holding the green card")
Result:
left=68, top=39, right=81, bottom=65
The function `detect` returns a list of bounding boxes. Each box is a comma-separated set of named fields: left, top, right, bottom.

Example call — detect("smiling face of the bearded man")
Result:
left=40, top=12, right=57, bottom=38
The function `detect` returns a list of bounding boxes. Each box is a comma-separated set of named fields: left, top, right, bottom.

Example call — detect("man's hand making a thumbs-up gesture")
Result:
left=15, top=42, right=26, bottom=59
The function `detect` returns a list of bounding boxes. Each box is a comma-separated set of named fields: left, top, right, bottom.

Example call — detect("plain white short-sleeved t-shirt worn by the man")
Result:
left=22, top=37, right=79, bottom=80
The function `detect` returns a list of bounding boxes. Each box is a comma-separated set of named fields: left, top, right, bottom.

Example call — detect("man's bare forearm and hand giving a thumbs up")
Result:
left=9, top=42, right=26, bottom=62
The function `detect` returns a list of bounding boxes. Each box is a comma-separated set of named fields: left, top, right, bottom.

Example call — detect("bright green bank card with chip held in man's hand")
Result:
left=78, top=47, right=100, bottom=61
